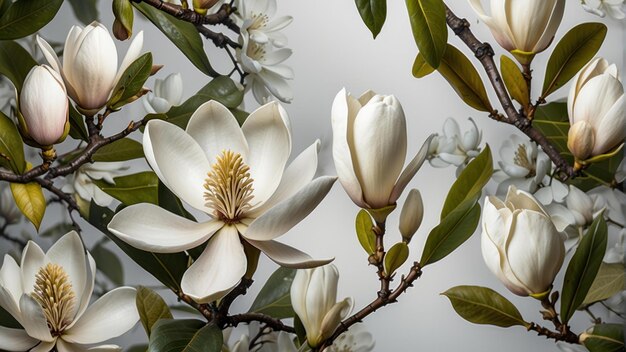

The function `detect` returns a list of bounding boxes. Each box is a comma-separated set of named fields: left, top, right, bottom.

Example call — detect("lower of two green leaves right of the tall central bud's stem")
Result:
left=420, top=197, right=480, bottom=266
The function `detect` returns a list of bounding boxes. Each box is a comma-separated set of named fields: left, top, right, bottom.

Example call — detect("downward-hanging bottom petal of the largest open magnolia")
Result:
left=181, top=225, right=247, bottom=303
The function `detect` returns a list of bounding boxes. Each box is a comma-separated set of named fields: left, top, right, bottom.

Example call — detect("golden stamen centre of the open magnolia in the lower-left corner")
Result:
left=32, top=263, right=76, bottom=336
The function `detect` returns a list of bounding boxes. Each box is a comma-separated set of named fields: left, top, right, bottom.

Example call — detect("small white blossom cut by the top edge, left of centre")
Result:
left=236, top=0, right=293, bottom=48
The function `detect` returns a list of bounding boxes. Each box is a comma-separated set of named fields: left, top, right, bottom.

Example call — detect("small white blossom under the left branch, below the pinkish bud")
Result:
left=61, top=162, right=128, bottom=207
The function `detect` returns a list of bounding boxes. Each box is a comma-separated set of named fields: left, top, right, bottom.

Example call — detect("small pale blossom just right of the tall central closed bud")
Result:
left=428, top=117, right=483, bottom=167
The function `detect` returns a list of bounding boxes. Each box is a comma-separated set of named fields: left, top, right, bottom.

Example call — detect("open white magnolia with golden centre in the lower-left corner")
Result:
left=0, top=231, right=139, bottom=352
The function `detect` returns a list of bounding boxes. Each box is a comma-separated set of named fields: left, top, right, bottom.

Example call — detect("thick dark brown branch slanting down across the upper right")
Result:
left=446, top=6, right=576, bottom=180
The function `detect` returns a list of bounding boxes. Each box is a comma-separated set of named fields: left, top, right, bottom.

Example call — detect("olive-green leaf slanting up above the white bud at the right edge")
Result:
left=541, top=23, right=607, bottom=98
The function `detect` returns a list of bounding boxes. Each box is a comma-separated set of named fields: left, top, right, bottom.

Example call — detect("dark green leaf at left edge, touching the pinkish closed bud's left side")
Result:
left=0, top=40, right=37, bottom=93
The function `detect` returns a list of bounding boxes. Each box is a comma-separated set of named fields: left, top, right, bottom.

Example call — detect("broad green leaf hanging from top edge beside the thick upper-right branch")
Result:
left=406, top=0, right=448, bottom=68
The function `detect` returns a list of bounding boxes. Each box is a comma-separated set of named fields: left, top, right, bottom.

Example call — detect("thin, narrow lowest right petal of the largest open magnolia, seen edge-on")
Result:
left=246, top=239, right=335, bottom=269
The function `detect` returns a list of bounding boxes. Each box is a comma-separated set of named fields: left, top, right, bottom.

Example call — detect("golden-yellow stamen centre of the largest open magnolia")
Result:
left=204, top=150, right=254, bottom=223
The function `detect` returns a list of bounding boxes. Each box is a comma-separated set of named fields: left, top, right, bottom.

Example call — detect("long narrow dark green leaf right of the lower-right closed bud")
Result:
left=561, top=214, right=608, bottom=324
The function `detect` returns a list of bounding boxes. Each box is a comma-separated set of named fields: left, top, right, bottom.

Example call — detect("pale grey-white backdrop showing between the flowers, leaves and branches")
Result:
left=35, top=0, right=626, bottom=352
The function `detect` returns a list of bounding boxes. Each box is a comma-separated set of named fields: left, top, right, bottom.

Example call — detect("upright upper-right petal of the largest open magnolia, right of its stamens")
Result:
left=241, top=102, right=291, bottom=203
